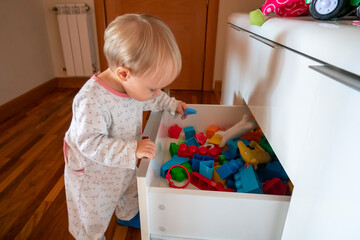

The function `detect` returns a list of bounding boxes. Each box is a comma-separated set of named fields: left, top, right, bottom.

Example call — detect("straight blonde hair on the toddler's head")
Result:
left=104, top=14, right=181, bottom=79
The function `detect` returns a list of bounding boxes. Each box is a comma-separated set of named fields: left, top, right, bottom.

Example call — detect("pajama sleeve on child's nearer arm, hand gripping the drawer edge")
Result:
left=73, top=97, right=137, bottom=169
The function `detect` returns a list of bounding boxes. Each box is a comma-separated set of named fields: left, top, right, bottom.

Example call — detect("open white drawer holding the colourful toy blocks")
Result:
left=137, top=104, right=290, bottom=240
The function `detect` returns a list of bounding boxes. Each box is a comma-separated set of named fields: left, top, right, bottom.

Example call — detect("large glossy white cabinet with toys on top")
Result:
left=222, top=14, right=360, bottom=240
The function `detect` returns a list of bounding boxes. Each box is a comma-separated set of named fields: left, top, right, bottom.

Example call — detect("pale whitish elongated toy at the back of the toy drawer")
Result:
left=216, top=114, right=257, bottom=147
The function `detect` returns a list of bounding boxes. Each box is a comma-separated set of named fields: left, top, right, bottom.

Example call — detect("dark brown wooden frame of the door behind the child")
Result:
left=94, top=0, right=219, bottom=91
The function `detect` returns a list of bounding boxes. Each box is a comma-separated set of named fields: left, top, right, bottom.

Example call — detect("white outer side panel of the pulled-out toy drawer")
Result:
left=149, top=188, right=289, bottom=240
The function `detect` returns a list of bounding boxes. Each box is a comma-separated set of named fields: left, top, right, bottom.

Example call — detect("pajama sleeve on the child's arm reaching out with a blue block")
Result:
left=144, top=91, right=181, bottom=115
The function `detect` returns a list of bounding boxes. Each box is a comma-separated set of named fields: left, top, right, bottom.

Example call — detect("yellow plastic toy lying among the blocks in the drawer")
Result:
left=238, top=141, right=271, bottom=170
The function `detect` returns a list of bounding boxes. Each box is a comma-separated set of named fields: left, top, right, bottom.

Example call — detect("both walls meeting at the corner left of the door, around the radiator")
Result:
left=0, top=0, right=99, bottom=105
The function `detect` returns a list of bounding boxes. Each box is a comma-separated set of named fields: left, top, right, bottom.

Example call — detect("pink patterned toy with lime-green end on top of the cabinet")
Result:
left=250, top=0, right=309, bottom=26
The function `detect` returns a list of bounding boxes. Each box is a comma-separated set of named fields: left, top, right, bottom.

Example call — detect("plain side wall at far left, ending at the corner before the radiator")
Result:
left=0, top=0, right=54, bottom=105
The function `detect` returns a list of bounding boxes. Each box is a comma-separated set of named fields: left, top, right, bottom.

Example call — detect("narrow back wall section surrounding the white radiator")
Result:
left=42, top=0, right=100, bottom=77
